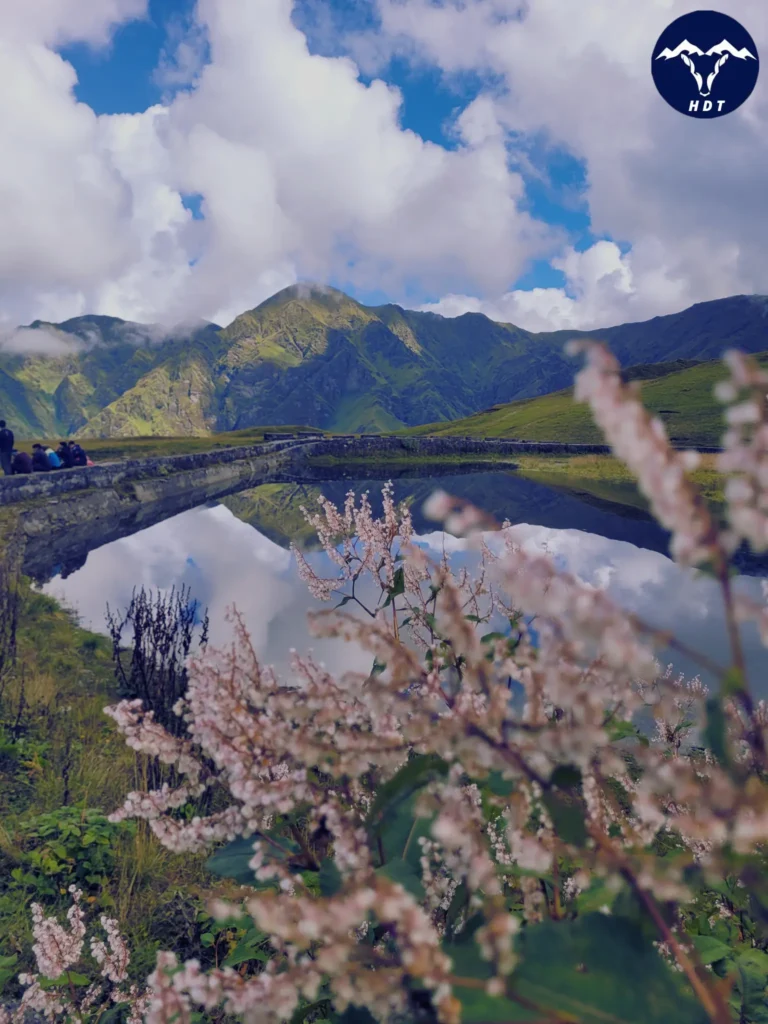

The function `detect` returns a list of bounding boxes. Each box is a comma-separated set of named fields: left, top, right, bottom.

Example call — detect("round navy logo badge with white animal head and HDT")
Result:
left=651, top=10, right=760, bottom=118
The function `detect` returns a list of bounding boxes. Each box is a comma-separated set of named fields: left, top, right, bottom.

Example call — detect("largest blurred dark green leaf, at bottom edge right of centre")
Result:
left=511, top=913, right=709, bottom=1024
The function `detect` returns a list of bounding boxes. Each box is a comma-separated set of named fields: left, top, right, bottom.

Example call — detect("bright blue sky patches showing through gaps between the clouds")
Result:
left=59, top=0, right=596, bottom=303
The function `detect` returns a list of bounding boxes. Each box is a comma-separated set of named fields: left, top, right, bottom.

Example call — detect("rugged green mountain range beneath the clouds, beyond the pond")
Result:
left=0, top=285, right=768, bottom=437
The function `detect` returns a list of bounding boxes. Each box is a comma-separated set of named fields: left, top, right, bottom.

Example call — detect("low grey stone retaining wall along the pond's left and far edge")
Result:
left=0, top=435, right=717, bottom=580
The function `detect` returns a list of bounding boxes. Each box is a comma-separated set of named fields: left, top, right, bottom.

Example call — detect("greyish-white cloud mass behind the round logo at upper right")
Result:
left=370, top=0, right=768, bottom=329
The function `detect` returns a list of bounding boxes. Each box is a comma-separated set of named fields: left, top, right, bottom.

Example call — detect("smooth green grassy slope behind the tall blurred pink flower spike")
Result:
left=408, top=352, right=768, bottom=444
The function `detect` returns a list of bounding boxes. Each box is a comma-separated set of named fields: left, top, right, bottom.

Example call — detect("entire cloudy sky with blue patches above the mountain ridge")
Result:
left=0, top=0, right=768, bottom=335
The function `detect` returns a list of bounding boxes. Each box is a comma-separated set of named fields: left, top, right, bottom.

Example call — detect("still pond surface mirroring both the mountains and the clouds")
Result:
left=37, top=472, right=768, bottom=695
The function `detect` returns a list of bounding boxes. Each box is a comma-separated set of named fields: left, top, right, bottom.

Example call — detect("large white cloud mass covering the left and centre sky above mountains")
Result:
left=0, top=0, right=557, bottom=331
